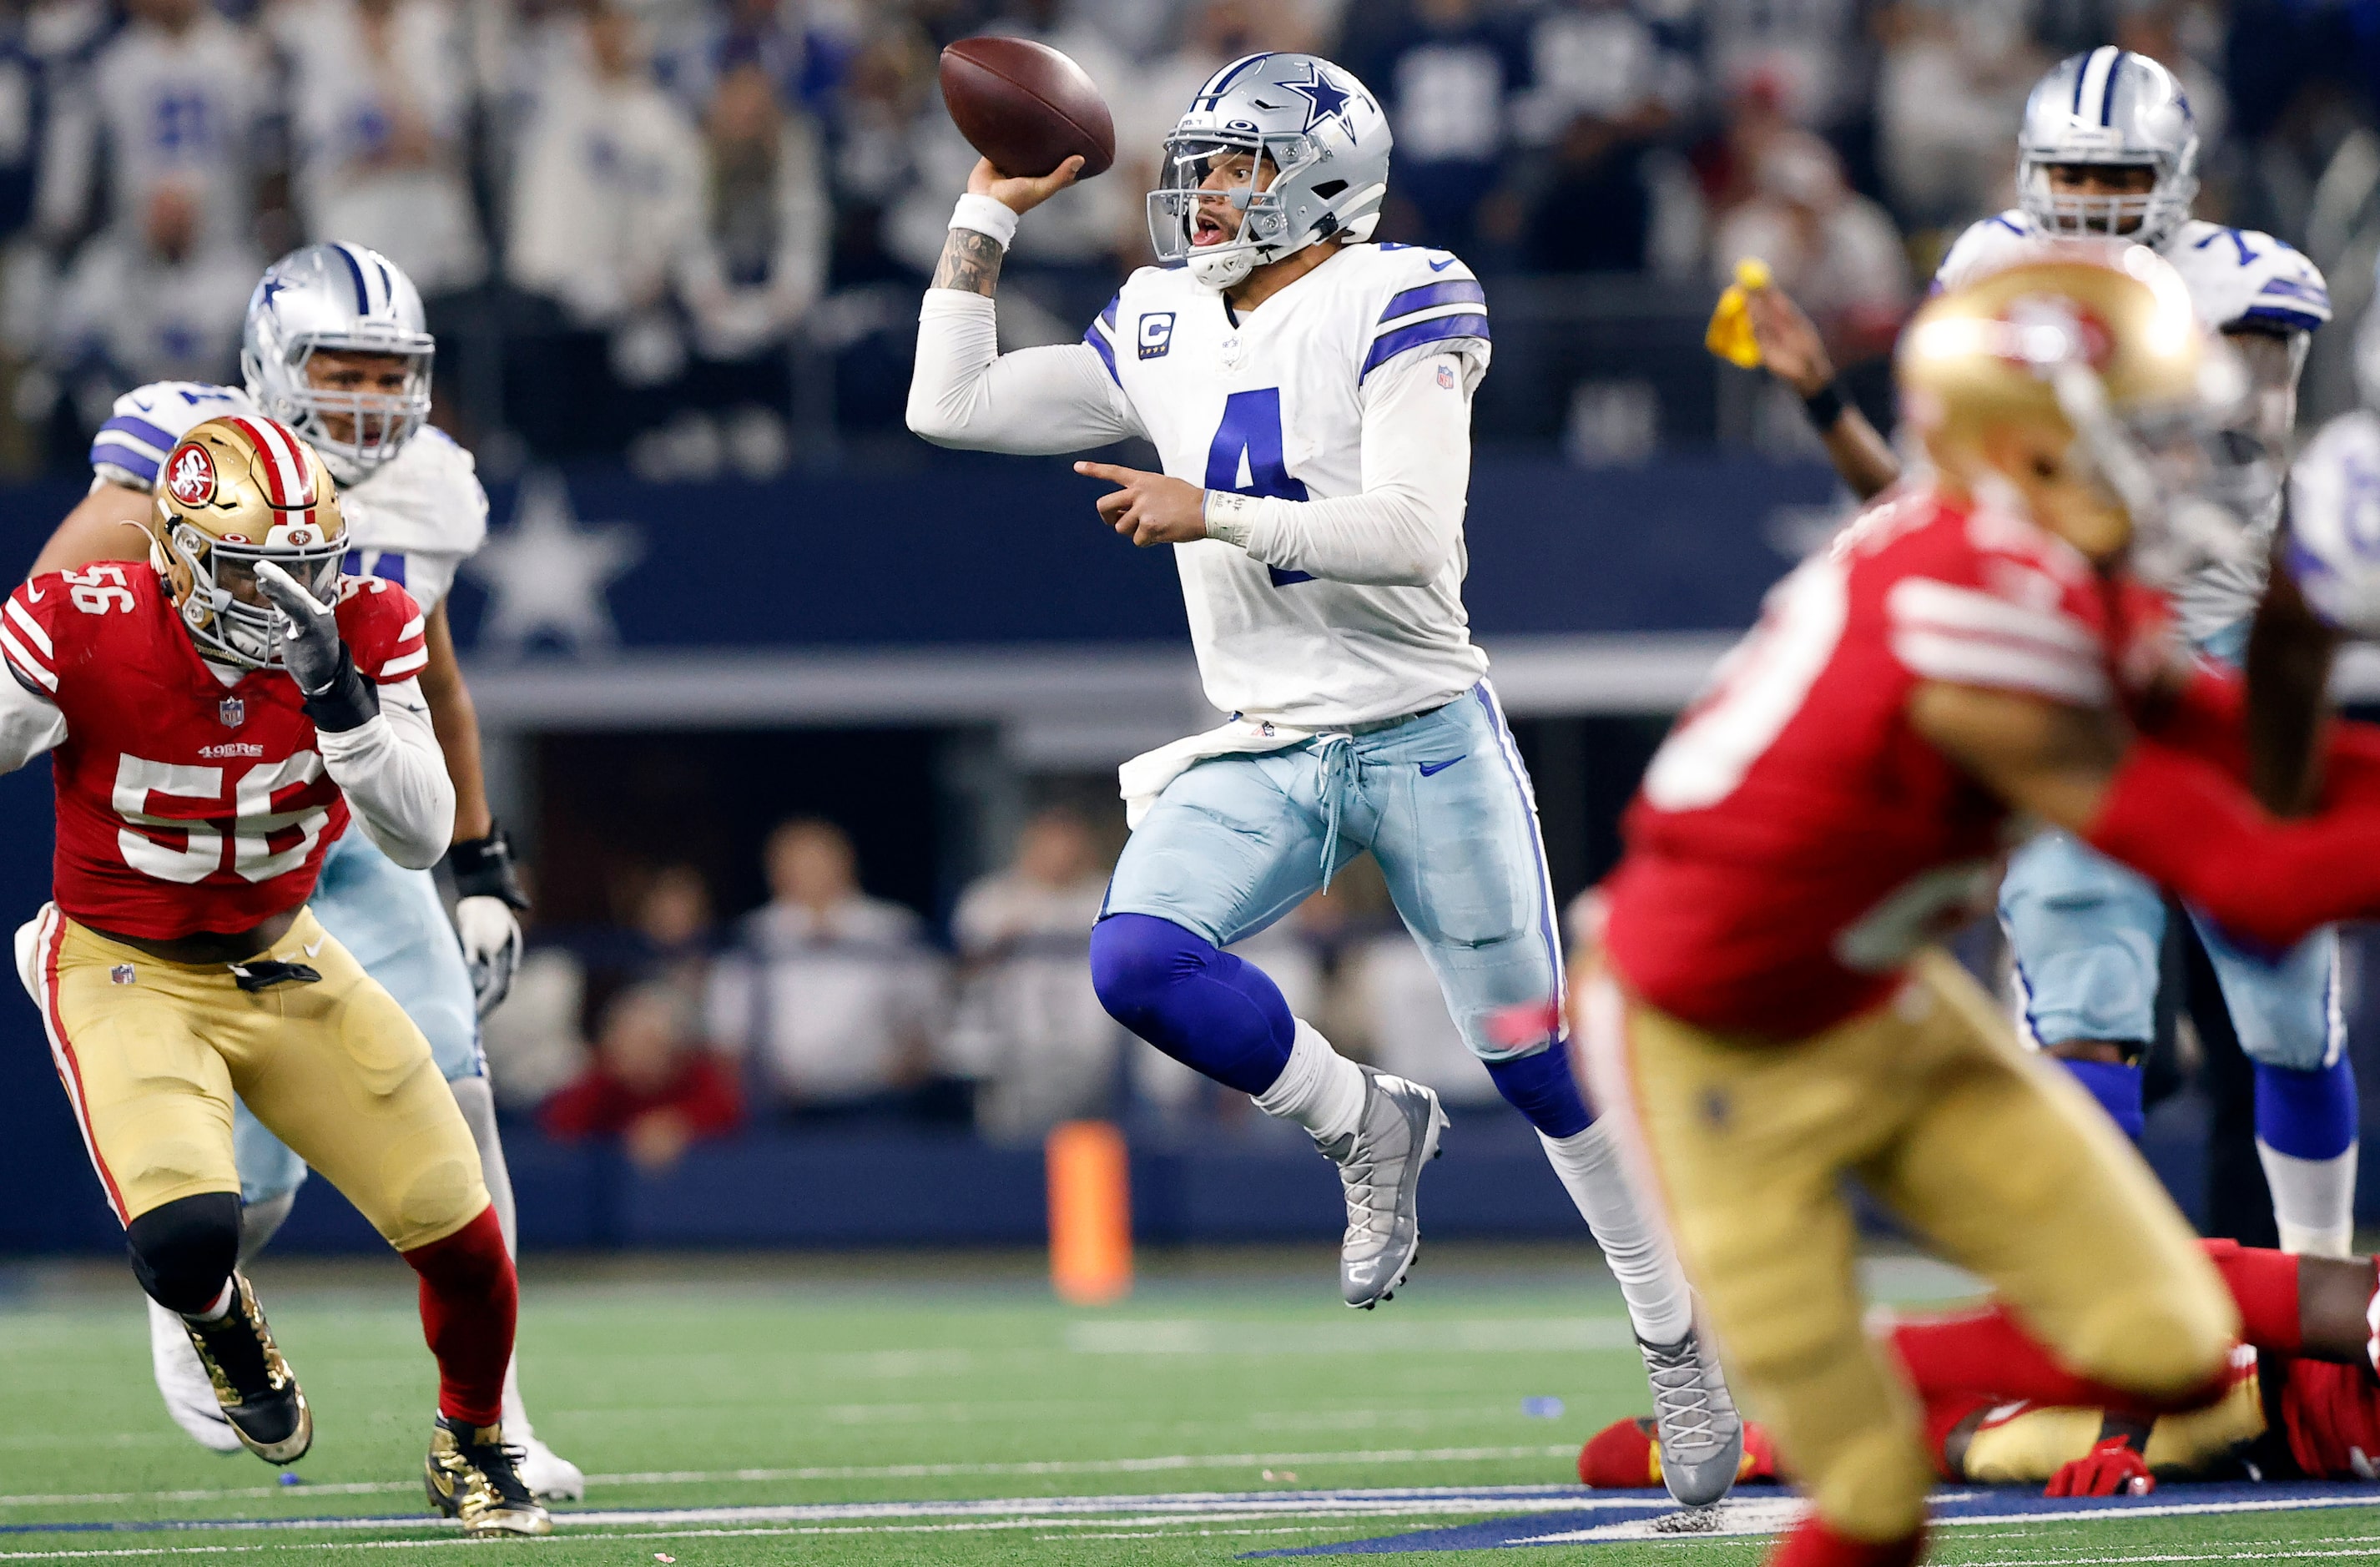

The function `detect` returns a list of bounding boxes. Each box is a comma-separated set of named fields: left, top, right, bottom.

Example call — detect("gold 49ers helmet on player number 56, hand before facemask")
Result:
left=150, top=416, right=347, bottom=669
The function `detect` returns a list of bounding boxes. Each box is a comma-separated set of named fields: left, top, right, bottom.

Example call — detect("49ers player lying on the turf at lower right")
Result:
left=1578, top=1241, right=2380, bottom=1495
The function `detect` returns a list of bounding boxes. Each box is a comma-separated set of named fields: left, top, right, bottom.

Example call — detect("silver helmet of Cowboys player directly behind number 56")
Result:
left=240, top=245, right=436, bottom=483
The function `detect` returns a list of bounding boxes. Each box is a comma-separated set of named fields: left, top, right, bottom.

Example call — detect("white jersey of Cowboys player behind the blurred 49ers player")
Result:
left=1935, top=207, right=2330, bottom=643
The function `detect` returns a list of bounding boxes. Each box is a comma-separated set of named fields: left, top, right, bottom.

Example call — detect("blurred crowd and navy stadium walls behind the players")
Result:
left=0, top=0, right=2380, bottom=1252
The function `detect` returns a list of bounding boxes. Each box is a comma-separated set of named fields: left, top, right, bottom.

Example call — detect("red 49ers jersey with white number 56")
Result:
left=0, top=564, right=428, bottom=940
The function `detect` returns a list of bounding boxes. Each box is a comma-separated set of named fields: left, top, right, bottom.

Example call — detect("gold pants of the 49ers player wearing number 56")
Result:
left=19, top=905, right=488, bottom=1250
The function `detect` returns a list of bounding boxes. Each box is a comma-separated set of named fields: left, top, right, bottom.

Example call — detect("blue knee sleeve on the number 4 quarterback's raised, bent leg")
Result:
left=1090, top=915, right=1297, bottom=1093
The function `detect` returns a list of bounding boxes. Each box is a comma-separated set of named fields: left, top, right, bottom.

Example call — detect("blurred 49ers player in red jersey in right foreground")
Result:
left=1576, top=248, right=2380, bottom=1567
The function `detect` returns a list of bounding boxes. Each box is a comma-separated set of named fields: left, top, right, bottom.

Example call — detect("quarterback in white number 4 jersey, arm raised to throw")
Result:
left=909, top=55, right=1742, bottom=1503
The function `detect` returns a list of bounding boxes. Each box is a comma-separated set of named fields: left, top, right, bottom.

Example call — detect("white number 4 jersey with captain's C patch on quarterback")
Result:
left=1086, top=245, right=1490, bottom=728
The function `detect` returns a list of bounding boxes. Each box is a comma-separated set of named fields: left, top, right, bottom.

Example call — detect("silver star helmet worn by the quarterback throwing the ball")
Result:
left=1150, top=55, right=1392, bottom=288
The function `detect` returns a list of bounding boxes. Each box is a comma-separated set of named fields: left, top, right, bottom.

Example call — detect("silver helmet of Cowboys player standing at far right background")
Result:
left=2016, top=45, right=2199, bottom=248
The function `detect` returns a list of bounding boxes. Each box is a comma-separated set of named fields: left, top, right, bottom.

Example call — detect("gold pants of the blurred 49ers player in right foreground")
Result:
left=1583, top=950, right=2240, bottom=1541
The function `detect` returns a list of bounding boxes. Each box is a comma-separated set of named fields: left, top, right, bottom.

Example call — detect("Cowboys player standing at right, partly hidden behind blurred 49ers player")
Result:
left=1749, top=45, right=2356, bottom=1257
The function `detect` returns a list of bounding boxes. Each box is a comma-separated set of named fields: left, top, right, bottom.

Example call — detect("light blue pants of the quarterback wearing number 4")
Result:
left=1102, top=681, right=1561, bottom=1060
